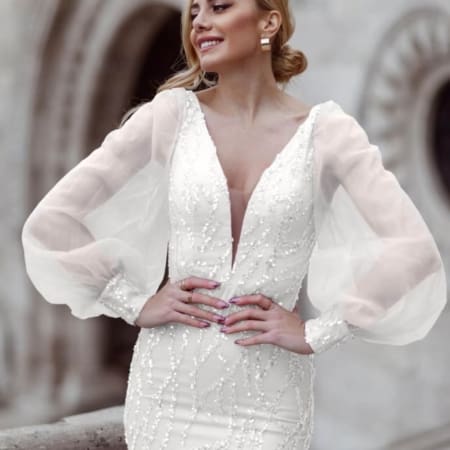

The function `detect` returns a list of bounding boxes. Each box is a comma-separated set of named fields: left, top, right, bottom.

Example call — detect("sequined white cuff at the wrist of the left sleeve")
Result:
left=98, top=272, right=149, bottom=326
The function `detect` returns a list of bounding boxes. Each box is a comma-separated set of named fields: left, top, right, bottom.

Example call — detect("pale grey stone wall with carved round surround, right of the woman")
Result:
left=292, top=0, right=450, bottom=450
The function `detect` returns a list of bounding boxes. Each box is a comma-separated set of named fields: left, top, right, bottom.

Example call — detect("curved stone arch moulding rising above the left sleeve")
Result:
left=31, top=0, right=182, bottom=198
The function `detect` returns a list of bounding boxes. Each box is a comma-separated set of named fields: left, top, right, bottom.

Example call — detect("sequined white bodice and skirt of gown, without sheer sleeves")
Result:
left=124, top=91, right=326, bottom=450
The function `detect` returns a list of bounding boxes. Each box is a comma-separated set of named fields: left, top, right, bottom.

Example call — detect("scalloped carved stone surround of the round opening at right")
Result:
left=358, top=7, right=450, bottom=278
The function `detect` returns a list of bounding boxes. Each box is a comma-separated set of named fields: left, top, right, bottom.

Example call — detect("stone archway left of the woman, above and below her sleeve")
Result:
left=24, top=0, right=184, bottom=420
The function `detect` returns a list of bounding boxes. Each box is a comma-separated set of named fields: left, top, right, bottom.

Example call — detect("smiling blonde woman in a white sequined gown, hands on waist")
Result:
left=23, top=0, right=446, bottom=450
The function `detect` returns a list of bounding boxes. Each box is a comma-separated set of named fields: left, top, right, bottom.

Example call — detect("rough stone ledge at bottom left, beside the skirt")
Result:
left=0, top=406, right=127, bottom=450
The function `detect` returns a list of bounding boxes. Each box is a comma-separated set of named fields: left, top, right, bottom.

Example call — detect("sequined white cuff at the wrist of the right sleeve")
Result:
left=305, top=309, right=354, bottom=353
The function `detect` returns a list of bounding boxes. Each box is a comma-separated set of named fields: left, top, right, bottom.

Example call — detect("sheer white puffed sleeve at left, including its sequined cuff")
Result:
left=22, top=90, right=182, bottom=325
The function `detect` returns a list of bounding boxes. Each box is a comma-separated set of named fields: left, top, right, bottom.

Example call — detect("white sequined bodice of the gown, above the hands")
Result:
left=169, top=91, right=320, bottom=309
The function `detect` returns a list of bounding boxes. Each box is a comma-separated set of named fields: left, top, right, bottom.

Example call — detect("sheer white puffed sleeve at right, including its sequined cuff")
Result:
left=305, top=100, right=447, bottom=353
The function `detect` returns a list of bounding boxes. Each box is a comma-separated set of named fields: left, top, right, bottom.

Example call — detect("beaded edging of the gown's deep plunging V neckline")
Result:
left=186, top=90, right=319, bottom=273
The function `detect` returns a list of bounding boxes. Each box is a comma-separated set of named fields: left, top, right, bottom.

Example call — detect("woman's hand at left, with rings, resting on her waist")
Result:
left=134, top=277, right=230, bottom=328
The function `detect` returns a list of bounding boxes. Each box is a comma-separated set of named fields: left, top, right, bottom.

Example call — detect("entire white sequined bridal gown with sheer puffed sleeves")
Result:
left=23, top=88, right=446, bottom=450
